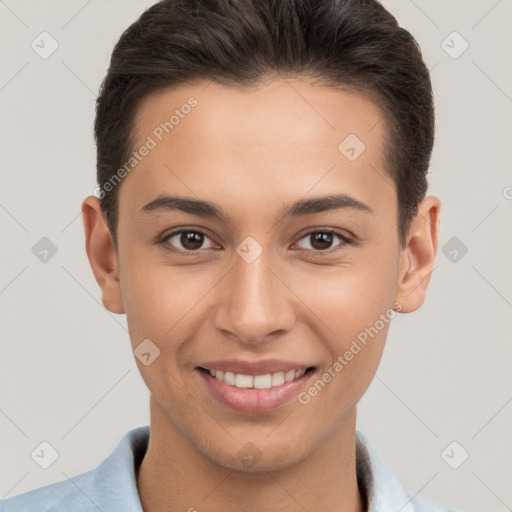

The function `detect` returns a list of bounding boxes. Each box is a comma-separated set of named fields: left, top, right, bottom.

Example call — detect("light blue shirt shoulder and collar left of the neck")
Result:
left=0, top=426, right=149, bottom=512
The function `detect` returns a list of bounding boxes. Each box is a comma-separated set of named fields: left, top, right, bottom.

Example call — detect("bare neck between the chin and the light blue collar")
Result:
left=137, top=398, right=364, bottom=512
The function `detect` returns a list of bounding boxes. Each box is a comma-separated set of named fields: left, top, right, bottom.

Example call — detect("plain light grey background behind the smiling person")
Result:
left=0, top=0, right=512, bottom=512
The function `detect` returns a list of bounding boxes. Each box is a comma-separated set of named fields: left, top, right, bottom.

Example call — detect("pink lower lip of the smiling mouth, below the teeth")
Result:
left=197, top=369, right=315, bottom=414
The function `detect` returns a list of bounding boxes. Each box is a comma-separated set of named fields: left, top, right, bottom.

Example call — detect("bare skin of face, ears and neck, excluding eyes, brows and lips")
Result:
left=82, top=78, right=441, bottom=512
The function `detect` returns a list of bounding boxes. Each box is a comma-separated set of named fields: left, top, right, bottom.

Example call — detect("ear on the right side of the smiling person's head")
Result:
left=395, top=196, right=441, bottom=313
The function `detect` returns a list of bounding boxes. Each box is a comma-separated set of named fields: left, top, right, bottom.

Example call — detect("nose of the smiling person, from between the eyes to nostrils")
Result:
left=214, top=251, right=295, bottom=345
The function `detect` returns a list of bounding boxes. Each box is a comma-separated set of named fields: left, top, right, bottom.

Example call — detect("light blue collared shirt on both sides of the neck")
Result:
left=0, top=426, right=455, bottom=512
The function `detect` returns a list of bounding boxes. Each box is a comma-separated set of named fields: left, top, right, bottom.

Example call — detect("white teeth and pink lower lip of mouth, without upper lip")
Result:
left=197, top=366, right=316, bottom=415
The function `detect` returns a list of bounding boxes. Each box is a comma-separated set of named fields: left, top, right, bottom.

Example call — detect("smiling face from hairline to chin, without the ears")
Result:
left=82, top=79, right=438, bottom=469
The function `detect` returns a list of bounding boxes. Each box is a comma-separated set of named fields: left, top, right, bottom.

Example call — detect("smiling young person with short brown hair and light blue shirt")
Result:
left=2, top=0, right=456, bottom=512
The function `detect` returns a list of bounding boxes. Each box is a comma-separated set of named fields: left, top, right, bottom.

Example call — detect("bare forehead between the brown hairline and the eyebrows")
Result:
left=123, top=79, right=394, bottom=220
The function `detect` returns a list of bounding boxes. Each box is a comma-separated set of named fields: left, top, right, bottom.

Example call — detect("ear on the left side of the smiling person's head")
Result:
left=82, top=196, right=125, bottom=314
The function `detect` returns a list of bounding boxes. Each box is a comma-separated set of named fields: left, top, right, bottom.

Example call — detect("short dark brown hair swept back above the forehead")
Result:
left=94, top=0, right=435, bottom=249
